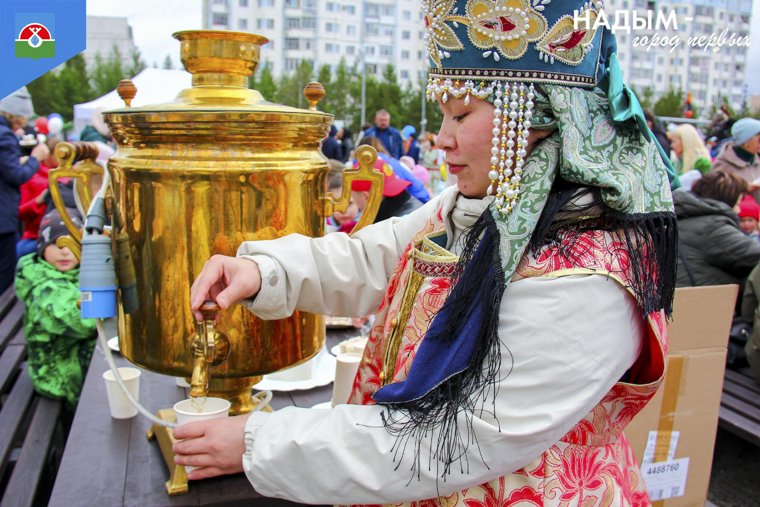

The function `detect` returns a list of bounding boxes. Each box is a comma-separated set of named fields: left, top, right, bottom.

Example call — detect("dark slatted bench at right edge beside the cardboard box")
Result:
left=718, top=368, right=760, bottom=446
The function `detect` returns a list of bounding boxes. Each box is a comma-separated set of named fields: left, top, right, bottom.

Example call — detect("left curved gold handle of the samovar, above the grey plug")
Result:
left=48, top=141, right=103, bottom=246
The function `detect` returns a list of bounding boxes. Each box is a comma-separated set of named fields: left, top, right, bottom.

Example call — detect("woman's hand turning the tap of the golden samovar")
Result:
left=190, top=255, right=261, bottom=320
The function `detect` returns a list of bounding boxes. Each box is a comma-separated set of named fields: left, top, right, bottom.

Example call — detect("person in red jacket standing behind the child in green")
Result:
left=16, top=138, right=61, bottom=259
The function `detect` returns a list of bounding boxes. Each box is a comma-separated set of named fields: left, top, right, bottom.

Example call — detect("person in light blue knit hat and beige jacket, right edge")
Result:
left=713, top=118, right=760, bottom=202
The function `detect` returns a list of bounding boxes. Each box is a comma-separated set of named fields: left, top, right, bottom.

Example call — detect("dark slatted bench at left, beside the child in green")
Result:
left=0, top=286, right=65, bottom=507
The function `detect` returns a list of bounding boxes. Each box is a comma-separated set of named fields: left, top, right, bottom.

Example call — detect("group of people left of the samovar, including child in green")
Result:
left=0, top=88, right=96, bottom=420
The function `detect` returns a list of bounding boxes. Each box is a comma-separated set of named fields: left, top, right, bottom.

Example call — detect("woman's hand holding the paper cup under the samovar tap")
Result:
left=172, top=414, right=248, bottom=480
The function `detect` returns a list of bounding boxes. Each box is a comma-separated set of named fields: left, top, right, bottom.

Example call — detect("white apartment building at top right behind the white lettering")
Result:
left=605, top=0, right=752, bottom=113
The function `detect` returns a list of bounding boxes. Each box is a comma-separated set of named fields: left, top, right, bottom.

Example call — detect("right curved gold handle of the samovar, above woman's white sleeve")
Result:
left=325, top=145, right=384, bottom=234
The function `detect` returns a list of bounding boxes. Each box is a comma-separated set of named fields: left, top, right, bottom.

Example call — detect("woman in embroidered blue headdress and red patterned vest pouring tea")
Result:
left=174, top=0, right=677, bottom=506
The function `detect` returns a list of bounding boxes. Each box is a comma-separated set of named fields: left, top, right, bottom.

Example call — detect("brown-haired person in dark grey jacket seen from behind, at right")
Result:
left=673, top=171, right=760, bottom=287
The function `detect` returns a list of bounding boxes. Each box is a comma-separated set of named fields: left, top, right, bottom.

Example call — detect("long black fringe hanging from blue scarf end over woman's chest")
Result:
left=383, top=210, right=506, bottom=482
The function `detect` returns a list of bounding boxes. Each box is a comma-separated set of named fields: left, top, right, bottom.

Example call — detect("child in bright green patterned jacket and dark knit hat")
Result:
left=16, top=210, right=97, bottom=414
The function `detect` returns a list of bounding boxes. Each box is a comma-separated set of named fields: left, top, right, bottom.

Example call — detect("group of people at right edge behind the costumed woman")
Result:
left=667, top=112, right=760, bottom=382
